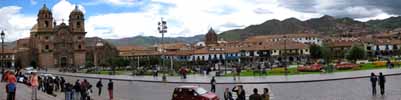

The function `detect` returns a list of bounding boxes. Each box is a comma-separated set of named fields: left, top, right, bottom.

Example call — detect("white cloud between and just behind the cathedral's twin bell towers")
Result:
left=52, top=0, right=85, bottom=24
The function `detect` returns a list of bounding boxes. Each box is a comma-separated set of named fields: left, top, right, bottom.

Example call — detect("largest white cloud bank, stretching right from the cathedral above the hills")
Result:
left=86, top=0, right=321, bottom=38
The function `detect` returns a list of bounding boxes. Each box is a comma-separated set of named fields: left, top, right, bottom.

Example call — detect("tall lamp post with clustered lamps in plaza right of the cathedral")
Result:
left=157, top=18, right=167, bottom=81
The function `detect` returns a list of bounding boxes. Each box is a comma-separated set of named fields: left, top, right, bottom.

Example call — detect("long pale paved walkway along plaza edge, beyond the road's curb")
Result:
left=43, top=68, right=401, bottom=84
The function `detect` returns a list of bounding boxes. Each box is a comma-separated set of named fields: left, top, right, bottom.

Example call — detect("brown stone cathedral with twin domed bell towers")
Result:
left=29, top=5, right=86, bottom=68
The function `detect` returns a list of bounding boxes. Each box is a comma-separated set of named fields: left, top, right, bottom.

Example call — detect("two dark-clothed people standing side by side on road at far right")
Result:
left=370, top=72, right=386, bottom=95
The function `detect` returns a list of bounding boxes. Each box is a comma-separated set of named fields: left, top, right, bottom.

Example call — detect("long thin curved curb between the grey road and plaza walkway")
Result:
left=43, top=72, right=401, bottom=84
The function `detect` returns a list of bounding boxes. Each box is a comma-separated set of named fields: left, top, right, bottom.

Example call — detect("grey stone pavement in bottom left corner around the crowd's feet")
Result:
left=0, top=82, right=64, bottom=100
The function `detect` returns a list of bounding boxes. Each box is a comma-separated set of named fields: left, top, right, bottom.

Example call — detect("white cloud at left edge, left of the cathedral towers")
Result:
left=0, top=6, right=36, bottom=41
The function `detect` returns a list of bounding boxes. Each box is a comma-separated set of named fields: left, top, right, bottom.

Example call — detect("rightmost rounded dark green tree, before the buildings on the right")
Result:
left=345, top=45, right=366, bottom=62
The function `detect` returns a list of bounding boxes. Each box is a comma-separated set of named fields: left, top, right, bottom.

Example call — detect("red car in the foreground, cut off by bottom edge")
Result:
left=172, top=86, right=219, bottom=100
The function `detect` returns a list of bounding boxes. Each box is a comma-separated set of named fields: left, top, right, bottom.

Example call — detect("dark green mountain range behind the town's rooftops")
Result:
left=107, top=15, right=401, bottom=46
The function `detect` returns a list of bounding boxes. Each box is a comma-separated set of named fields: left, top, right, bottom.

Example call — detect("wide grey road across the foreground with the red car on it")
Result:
left=56, top=75, right=401, bottom=100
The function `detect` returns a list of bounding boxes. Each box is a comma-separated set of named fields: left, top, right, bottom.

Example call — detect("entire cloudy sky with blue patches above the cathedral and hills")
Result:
left=0, top=0, right=401, bottom=41
